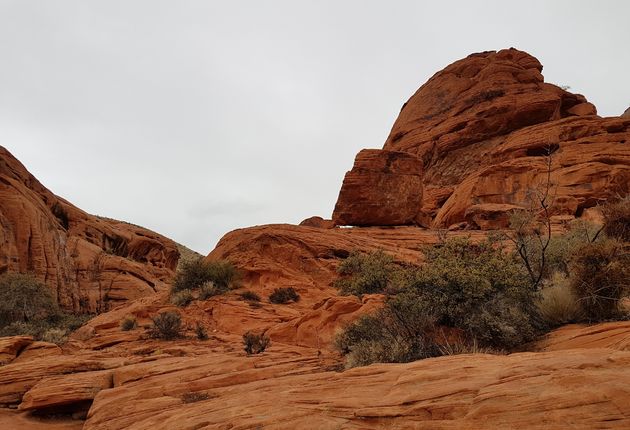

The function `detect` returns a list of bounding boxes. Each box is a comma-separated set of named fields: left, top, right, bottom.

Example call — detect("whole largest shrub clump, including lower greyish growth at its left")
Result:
left=336, top=238, right=542, bottom=366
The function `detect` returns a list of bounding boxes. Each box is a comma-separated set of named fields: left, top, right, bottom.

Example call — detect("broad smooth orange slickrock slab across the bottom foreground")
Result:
left=85, top=349, right=630, bottom=430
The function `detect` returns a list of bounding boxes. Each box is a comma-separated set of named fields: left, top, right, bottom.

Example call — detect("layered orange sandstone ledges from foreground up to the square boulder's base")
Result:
left=0, top=225, right=630, bottom=430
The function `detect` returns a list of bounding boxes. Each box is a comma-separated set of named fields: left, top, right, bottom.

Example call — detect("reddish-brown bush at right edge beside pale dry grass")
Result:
left=570, top=239, right=630, bottom=321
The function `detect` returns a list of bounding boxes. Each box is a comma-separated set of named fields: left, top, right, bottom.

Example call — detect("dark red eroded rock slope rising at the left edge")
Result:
left=0, top=147, right=179, bottom=312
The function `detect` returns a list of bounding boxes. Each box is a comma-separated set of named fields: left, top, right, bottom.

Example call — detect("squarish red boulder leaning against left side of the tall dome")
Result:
left=333, top=149, right=422, bottom=226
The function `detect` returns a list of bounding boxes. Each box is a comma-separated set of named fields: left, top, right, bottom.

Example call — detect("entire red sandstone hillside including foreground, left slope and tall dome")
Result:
left=0, top=50, right=630, bottom=430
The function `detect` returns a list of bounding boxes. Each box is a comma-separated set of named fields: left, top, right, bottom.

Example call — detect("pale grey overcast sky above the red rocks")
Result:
left=0, top=0, right=630, bottom=254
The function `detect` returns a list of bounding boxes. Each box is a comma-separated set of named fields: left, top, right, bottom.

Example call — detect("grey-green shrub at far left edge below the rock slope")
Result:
left=0, top=273, right=58, bottom=326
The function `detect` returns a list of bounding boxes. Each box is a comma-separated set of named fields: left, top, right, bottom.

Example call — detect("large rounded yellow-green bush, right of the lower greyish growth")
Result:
left=412, top=238, right=539, bottom=348
